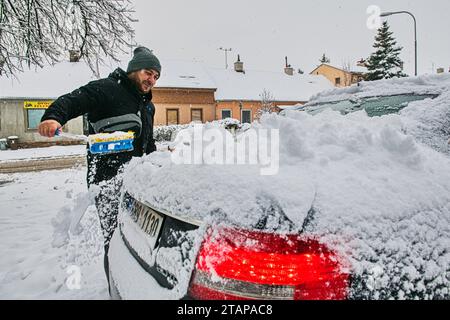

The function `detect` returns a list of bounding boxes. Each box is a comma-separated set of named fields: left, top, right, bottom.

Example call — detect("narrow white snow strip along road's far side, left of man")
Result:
left=0, top=145, right=86, bottom=161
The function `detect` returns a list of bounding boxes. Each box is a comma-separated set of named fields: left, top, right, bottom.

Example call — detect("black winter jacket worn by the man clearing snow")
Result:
left=41, top=68, right=156, bottom=184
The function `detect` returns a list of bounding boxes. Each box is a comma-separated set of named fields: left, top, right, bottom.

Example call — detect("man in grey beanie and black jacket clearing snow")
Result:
left=39, top=47, right=161, bottom=281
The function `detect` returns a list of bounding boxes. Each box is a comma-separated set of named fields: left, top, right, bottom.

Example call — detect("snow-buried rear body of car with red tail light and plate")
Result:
left=109, top=75, right=450, bottom=299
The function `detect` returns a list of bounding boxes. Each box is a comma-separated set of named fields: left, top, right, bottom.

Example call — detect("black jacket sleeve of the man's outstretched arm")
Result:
left=41, top=81, right=102, bottom=125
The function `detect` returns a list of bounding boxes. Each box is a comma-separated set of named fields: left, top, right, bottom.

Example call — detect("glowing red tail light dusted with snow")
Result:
left=189, top=228, right=349, bottom=300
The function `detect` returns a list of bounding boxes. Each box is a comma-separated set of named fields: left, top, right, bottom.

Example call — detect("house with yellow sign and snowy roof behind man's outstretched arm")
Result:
left=0, top=62, right=99, bottom=146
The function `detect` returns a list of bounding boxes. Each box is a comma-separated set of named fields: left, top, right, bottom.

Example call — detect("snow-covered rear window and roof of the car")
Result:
left=283, top=74, right=450, bottom=155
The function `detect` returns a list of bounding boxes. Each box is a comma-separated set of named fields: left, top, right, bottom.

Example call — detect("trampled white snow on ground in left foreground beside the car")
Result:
left=0, top=169, right=109, bottom=299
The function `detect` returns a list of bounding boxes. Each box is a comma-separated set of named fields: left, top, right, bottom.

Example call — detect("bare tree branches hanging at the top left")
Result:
left=0, top=0, right=135, bottom=76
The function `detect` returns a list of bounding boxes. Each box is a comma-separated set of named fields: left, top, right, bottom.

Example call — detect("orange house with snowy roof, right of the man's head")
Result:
left=153, top=58, right=333, bottom=125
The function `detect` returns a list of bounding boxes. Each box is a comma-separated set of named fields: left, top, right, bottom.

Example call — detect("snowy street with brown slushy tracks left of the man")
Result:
left=0, top=145, right=86, bottom=173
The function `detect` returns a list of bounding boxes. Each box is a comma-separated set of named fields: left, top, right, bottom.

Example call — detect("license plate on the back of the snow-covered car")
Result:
left=134, top=201, right=164, bottom=249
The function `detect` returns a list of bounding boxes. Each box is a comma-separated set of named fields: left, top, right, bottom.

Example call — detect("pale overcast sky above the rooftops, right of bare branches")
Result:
left=132, top=0, right=450, bottom=74
